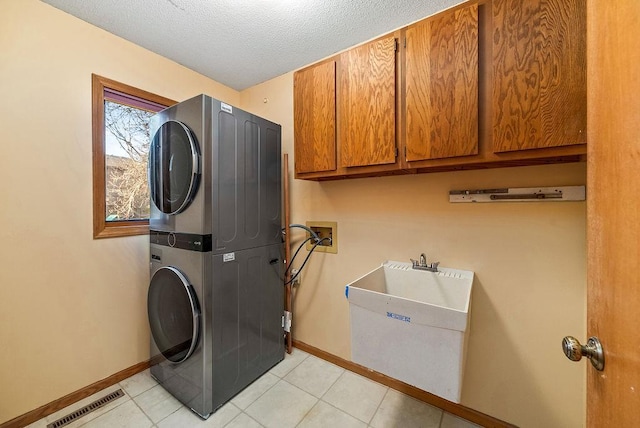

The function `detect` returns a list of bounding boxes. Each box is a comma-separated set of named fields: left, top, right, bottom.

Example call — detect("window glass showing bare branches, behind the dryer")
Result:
left=104, top=100, right=154, bottom=222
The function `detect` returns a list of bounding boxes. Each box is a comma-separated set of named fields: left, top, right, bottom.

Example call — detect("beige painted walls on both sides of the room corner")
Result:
left=0, top=0, right=586, bottom=427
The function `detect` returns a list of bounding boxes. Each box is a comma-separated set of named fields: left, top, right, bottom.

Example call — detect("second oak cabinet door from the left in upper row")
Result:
left=338, top=36, right=396, bottom=167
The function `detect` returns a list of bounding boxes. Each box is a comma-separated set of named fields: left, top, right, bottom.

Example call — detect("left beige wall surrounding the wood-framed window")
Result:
left=0, top=0, right=239, bottom=423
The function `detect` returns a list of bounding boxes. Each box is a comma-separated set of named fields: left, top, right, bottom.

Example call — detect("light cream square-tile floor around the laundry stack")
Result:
left=29, top=348, right=477, bottom=428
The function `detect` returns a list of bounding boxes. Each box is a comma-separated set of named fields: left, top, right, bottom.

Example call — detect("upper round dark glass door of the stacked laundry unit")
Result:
left=149, top=120, right=200, bottom=214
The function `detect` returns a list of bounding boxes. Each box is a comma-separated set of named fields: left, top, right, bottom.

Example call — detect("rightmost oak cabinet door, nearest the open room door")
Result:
left=492, top=0, right=587, bottom=152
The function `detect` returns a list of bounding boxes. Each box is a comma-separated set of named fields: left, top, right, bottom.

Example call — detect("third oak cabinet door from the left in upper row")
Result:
left=405, top=5, right=478, bottom=161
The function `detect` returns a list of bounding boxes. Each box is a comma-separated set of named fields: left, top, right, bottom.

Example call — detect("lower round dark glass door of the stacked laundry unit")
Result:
left=147, top=267, right=200, bottom=363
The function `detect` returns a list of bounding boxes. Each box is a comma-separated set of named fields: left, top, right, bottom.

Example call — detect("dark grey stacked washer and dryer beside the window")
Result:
left=147, top=95, right=284, bottom=418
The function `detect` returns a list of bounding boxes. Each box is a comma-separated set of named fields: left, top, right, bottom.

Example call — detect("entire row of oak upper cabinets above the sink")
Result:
left=294, top=0, right=587, bottom=180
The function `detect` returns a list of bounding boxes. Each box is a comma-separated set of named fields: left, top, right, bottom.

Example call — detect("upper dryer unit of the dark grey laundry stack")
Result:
left=149, top=95, right=282, bottom=247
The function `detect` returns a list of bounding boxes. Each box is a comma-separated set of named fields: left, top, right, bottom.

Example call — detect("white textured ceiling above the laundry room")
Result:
left=42, top=0, right=461, bottom=90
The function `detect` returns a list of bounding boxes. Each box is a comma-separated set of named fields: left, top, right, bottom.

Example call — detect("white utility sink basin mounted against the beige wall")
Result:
left=346, top=261, right=474, bottom=403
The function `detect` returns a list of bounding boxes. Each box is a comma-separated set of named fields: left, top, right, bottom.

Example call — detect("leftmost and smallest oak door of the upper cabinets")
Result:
left=293, top=61, right=336, bottom=173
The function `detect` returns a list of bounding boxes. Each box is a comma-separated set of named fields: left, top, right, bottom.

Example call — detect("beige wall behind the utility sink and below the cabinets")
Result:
left=241, top=73, right=586, bottom=427
